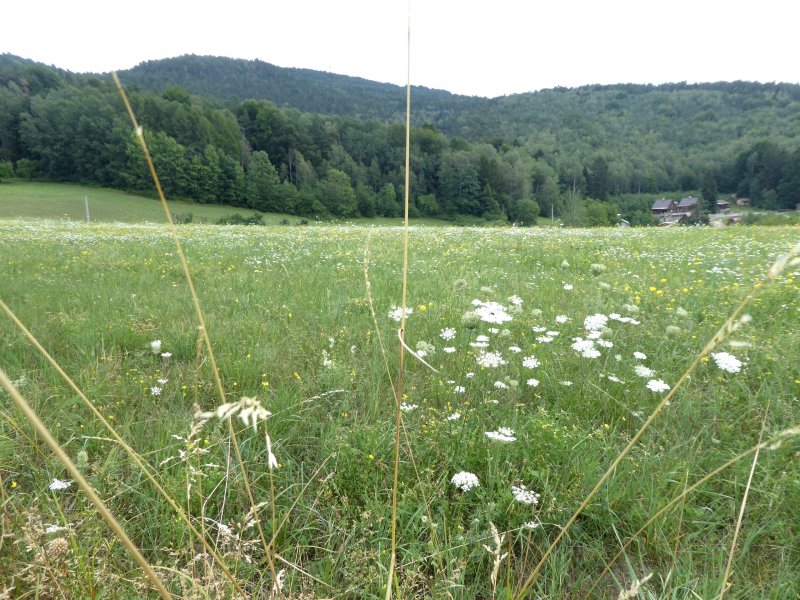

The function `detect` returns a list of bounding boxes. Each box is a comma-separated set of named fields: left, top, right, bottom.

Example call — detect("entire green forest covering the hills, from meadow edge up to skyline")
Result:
left=0, top=54, right=800, bottom=225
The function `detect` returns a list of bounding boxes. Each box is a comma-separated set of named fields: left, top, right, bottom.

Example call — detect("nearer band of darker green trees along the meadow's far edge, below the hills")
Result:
left=0, top=55, right=800, bottom=224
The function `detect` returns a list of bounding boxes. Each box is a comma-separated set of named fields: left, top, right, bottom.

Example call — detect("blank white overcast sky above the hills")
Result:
left=6, top=0, right=800, bottom=97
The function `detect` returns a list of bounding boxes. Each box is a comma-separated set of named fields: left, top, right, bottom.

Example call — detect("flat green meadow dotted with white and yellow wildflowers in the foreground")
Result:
left=0, top=220, right=800, bottom=599
